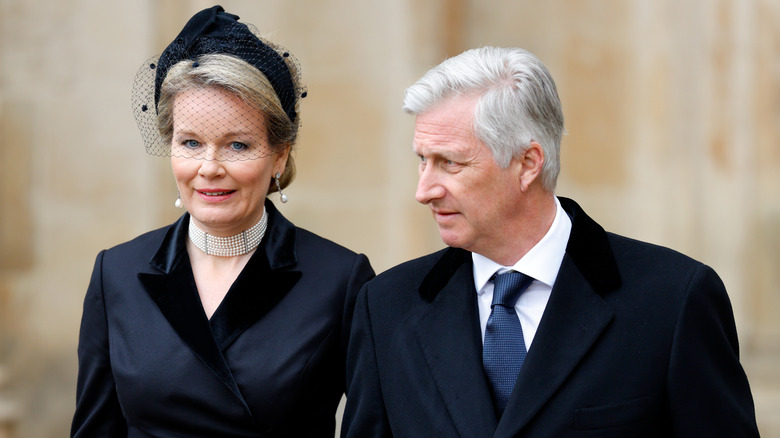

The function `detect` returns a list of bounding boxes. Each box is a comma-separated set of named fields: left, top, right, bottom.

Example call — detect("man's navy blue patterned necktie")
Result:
left=482, top=271, right=534, bottom=418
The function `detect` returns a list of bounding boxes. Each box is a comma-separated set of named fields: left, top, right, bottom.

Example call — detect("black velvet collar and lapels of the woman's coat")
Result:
left=138, top=201, right=301, bottom=410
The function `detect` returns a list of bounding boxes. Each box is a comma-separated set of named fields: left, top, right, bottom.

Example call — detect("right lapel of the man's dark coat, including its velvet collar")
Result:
left=494, top=198, right=620, bottom=437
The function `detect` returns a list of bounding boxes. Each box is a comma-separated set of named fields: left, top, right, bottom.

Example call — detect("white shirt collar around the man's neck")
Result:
left=471, top=198, right=571, bottom=294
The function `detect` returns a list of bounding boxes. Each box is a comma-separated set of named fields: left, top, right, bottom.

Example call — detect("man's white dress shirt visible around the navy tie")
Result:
left=471, top=198, right=571, bottom=350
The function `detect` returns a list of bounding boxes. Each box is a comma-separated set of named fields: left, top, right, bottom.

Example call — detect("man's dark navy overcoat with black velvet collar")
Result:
left=342, top=199, right=758, bottom=438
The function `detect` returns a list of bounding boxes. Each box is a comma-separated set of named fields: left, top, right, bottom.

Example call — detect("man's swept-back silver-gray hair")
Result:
left=403, top=47, right=564, bottom=192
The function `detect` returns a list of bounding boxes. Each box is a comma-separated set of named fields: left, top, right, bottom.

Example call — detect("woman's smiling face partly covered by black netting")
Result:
left=171, top=87, right=289, bottom=236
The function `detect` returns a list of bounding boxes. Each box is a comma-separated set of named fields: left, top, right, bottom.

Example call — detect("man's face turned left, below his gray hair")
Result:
left=413, top=96, right=522, bottom=256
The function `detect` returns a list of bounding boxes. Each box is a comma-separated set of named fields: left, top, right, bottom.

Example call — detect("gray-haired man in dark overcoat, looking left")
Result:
left=342, top=47, right=758, bottom=438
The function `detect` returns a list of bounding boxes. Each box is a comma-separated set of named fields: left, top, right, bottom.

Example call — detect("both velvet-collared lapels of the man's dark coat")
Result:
left=415, top=198, right=621, bottom=437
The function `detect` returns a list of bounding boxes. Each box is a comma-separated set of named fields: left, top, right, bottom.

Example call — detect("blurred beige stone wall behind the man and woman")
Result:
left=0, top=0, right=780, bottom=438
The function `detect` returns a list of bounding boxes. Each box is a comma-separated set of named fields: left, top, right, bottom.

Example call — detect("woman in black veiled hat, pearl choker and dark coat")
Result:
left=71, top=6, right=373, bottom=437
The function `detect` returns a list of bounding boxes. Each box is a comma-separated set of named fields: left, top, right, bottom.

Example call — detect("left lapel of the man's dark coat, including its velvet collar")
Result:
left=415, top=248, right=496, bottom=437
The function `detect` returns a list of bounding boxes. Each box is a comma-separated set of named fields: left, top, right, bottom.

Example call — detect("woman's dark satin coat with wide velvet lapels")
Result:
left=71, top=201, right=373, bottom=438
